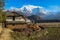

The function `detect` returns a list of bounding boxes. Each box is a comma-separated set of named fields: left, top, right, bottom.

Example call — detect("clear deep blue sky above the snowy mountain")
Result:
left=5, top=0, right=60, bottom=9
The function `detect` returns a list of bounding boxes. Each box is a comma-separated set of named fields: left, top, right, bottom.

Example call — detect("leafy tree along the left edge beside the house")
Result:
left=0, top=0, right=6, bottom=22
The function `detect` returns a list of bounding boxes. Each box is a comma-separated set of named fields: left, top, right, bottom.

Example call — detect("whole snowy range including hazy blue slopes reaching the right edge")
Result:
left=6, top=5, right=60, bottom=20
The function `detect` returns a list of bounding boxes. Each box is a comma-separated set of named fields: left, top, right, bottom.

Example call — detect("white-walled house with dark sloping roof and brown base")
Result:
left=5, top=11, right=31, bottom=28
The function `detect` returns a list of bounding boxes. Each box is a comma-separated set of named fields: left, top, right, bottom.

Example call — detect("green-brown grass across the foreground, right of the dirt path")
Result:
left=11, top=27, right=60, bottom=40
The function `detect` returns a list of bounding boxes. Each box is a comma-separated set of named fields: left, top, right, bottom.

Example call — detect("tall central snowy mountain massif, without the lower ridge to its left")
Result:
left=20, top=5, right=47, bottom=15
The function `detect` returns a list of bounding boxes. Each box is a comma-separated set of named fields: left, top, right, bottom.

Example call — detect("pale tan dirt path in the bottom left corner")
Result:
left=0, top=28, right=12, bottom=40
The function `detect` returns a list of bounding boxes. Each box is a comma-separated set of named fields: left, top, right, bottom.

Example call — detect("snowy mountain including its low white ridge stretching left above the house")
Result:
left=9, top=5, right=47, bottom=16
